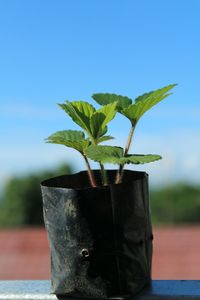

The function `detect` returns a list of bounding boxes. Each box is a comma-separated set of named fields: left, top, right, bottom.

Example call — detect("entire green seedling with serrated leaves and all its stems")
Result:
left=46, top=84, right=176, bottom=187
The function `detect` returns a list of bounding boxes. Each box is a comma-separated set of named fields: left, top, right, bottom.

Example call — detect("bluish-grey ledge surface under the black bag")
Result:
left=0, top=280, right=200, bottom=300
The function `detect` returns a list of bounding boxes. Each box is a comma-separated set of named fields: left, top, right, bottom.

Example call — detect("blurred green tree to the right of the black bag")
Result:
left=150, top=184, right=200, bottom=224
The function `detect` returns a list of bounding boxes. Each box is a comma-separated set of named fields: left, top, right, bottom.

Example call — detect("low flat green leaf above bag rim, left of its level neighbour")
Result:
left=85, top=145, right=123, bottom=164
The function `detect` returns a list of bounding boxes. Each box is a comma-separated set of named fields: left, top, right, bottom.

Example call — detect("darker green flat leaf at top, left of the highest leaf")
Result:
left=92, top=93, right=132, bottom=112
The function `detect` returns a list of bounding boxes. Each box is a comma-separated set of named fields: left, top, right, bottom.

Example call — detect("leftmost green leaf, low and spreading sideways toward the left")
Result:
left=45, top=130, right=90, bottom=153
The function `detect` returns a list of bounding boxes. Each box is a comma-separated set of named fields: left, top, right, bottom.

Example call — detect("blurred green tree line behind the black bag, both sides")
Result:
left=0, top=165, right=200, bottom=227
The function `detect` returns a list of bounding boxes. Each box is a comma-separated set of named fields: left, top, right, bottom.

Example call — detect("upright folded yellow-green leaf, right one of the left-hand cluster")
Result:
left=90, top=102, right=117, bottom=142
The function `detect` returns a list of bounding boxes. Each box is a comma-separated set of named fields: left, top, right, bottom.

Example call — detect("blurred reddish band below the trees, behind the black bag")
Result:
left=0, top=226, right=200, bottom=279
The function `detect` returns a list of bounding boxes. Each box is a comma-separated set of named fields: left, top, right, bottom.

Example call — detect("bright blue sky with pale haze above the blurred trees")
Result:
left=0, top=0, right=200, bottom=185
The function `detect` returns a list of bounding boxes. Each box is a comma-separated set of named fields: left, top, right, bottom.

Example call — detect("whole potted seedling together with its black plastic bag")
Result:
left=41, top=84, right=175, bottom=298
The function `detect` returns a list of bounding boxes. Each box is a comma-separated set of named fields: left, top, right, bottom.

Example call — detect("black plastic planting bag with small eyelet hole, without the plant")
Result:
left=41, top=171, right=152, bottom=298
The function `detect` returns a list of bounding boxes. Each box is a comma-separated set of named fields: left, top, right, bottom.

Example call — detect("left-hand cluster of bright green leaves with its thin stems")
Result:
left=46, top=101, right=117, bottom=187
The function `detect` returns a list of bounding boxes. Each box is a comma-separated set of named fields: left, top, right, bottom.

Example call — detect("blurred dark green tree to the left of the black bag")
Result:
left=0, top=165, right=72, bottom=227
